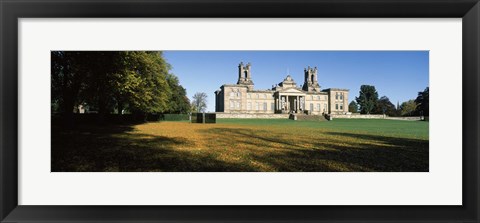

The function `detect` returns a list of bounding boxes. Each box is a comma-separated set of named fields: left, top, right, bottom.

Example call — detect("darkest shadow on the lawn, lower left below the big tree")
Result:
left=51, top=125, right=254, bottom=172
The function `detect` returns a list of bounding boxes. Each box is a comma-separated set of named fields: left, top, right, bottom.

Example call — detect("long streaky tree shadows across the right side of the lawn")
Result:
left=201, top=128, right=429, bottom=172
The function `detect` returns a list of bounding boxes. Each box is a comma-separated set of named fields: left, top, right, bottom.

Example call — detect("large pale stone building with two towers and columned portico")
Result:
left=215, top=63, right=348, bottom=115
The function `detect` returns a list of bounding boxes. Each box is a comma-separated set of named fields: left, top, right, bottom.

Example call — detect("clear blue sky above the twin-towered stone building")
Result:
left=164, top=51, right=429, bottom=111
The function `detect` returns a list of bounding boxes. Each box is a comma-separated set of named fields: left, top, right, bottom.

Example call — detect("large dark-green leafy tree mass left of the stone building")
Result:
left=51, top=51, right=181, bottom=122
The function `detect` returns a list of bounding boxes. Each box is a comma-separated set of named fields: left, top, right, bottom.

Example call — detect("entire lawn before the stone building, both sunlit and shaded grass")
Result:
left=52, top=119, right=429, bottom=172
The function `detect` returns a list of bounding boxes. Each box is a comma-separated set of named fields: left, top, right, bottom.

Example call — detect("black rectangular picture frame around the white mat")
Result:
left=0, top=0, right=480, bottom=222
